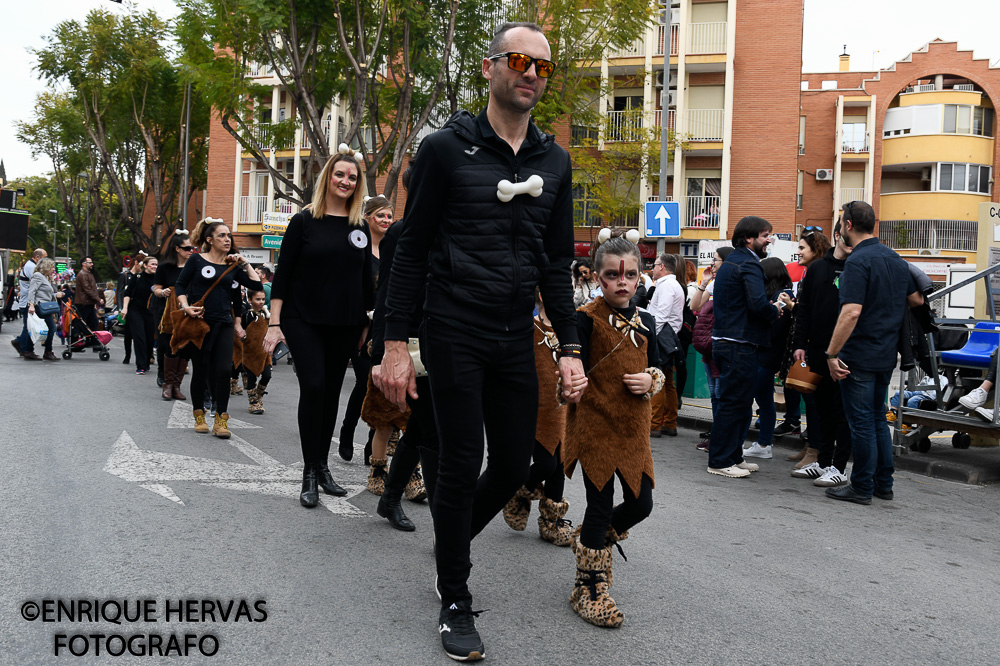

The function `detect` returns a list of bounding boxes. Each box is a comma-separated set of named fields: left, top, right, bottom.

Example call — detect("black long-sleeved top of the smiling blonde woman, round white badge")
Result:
left=271, top=211, right=375, bottom=326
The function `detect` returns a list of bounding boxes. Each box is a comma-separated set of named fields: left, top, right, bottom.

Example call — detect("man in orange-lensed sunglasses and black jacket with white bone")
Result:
left=381, top=23, right=587, bottom=660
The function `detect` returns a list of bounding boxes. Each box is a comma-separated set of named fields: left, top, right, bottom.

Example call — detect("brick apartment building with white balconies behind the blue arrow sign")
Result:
left=572, top=0, right=803, bottom=257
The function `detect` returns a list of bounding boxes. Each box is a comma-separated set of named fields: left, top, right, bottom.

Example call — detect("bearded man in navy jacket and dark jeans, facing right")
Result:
left=708, top=215, right=782, bottom=478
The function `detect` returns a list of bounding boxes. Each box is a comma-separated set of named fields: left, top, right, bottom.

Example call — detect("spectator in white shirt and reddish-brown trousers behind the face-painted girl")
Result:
left=647, top=252, right=684, bottom=437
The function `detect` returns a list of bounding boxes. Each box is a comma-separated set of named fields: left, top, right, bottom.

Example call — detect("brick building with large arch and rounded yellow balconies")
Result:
left=795, top=40, right=1000, bottom=276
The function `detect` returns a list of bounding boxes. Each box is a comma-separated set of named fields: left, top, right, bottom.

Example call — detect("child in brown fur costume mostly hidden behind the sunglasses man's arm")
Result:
left=503, top=289, right=570, bottom=546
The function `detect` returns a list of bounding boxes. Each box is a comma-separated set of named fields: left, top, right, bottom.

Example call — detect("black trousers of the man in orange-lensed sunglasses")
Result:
left=428, top=319, right=538, bottom=606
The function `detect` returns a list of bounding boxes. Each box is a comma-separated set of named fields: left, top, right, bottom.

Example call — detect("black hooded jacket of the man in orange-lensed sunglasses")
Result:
left=385, top=111, right=578, bottom=343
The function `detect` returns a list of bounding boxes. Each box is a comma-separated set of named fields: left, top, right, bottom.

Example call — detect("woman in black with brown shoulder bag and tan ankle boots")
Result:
left=170, top=218, right=263, bottom=439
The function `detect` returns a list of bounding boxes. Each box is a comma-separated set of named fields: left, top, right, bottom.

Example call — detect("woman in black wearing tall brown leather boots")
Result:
left=153, top=229, right=194, bottom=400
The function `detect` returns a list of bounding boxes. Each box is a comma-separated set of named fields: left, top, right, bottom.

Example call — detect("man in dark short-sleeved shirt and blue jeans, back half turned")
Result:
left=826, top=201, right=923, bottom=504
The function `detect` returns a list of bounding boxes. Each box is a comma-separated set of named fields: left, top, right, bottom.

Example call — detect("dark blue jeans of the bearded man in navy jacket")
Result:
left=708, top=340, right=757, bottom=469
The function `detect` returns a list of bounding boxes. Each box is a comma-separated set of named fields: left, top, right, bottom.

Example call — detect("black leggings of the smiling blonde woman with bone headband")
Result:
left=282, top=317, right=361, bottom=465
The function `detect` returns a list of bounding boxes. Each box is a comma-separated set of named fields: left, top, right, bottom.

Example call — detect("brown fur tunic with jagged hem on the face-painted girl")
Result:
left=563, top=297, right=653, bottom=497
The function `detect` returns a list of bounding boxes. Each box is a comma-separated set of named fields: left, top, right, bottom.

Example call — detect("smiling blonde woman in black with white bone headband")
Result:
left=258, top=144, right=375, bottom=507
